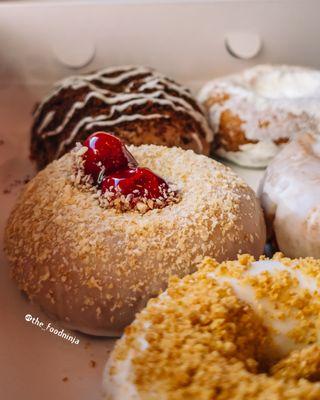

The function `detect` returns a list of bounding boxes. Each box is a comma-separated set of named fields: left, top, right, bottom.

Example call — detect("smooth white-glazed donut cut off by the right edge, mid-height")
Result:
left=259, top=134, right=320, bottom=258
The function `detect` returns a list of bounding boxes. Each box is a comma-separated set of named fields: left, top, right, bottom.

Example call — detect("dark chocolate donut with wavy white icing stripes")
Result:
left=31, top=66, right=213, bottom=168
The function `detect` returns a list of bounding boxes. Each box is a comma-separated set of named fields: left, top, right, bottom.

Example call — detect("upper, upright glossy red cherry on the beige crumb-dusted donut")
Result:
left=83, top=132, right=137, bottom=183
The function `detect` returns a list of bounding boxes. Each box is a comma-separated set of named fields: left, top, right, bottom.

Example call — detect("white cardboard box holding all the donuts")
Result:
left=0, top=0, right=320, bottom=400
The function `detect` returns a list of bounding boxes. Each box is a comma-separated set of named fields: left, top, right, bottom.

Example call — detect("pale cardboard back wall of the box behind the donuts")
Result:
left=0, top=0, right=320, bottom=84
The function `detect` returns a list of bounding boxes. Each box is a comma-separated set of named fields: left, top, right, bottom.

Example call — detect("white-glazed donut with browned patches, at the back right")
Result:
left=198, top=65, right=320, bottom=167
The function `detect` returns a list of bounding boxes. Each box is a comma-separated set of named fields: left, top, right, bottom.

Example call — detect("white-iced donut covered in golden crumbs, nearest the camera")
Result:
left=103, top=253, right=320, bottom=400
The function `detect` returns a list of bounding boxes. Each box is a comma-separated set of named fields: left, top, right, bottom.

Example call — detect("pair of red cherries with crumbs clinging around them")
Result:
left=78, top=132, right=179, bottom=213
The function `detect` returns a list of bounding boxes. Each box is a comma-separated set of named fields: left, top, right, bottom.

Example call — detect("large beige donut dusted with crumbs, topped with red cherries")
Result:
left=5, top=132, right=265, bottom=336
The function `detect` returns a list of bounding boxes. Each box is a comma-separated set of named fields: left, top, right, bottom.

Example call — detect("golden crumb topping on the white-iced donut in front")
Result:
left=110, top=254, right=320, bottom=400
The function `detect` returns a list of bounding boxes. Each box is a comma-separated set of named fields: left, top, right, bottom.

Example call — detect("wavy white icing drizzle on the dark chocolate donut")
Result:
left=34, top=66, right=213, bottom=156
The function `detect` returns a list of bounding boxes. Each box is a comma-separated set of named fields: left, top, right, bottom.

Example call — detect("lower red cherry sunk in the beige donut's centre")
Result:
left=101, top=167, right=169, bottom=199
